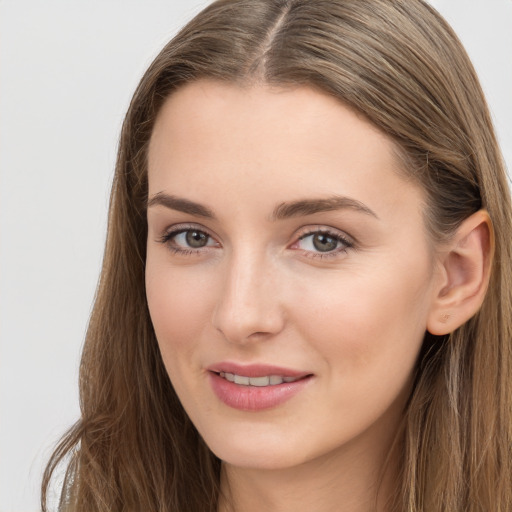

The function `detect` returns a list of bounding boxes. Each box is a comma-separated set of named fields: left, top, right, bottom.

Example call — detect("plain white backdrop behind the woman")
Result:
left=0, top=0, right=512, bottom=512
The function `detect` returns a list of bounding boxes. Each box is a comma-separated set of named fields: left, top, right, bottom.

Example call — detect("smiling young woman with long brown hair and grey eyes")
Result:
left=43, top=0, right=512, bottom=512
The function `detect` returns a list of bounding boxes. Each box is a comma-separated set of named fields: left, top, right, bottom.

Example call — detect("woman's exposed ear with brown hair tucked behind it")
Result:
left=427, top=210, right=494, bottom=335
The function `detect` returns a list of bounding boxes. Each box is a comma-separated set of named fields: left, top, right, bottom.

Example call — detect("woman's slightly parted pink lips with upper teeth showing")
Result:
left=208, top=363, right=313, bottom=411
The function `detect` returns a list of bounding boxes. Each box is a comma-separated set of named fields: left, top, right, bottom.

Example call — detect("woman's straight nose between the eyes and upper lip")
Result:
left=213, top=252, right=285, bottom=344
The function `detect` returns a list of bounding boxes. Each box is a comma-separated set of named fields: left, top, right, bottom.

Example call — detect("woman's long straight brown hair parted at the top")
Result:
left=42, top=0, right=512, bottom=512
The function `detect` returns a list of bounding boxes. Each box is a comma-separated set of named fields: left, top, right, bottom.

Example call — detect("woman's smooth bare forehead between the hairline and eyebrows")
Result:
left=148, top=80, right=421, bottom=223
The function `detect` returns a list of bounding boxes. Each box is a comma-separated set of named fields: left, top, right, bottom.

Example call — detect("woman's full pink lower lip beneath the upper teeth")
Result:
left=209, top=372, right=312, bottom=411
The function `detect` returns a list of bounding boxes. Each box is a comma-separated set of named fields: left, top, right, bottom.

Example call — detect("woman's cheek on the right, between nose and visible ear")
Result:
left=301, top=269, right=428, bottom=382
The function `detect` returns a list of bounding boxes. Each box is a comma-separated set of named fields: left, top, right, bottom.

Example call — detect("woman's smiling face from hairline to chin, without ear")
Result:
left=146, top=81, right=436, bottom=468
